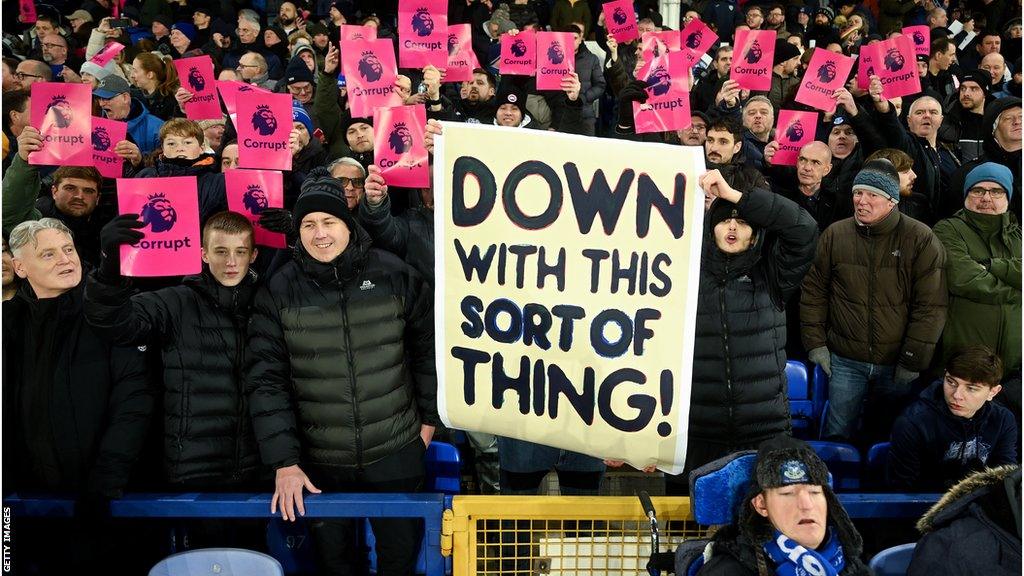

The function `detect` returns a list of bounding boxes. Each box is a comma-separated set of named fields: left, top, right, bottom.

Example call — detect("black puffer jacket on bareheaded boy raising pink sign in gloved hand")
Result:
left=85, top=272, right=260, bottom=485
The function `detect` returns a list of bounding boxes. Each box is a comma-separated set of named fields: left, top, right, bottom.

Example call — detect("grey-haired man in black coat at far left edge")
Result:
left=3, top=217, right=154, bottom=574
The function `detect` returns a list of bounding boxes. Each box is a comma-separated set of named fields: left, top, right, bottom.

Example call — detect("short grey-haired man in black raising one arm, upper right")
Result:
left=868, top=76, right=959, bottom=225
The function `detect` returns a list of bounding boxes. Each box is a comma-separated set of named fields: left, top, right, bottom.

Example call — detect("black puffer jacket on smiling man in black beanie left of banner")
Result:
left=247, top=222, right=438, bottom=469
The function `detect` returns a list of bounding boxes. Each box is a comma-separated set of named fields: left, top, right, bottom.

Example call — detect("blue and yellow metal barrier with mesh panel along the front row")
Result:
left=4, top=493, right=941, bottom=576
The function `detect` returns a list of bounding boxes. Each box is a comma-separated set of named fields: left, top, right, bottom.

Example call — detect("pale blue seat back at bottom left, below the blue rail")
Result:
left=150, top=548, right=285, bottom=576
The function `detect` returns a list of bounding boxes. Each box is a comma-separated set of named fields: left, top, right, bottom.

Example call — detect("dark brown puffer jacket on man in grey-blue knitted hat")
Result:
left=800, top=208, right=947, bottom=372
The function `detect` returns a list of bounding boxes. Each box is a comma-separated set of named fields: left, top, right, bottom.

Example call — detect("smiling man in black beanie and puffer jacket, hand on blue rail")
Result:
left=247, top=168, right=438, bottom=575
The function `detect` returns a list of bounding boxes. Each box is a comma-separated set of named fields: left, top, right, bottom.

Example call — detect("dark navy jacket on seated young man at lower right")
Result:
left=886, top=380, right=1017, bottom=492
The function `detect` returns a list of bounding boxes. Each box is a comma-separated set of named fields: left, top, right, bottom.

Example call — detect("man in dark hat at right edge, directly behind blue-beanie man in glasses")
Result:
left=942, top=96, right=1021, bottom=222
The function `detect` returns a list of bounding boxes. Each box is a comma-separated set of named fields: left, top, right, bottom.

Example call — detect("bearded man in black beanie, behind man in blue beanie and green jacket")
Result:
left=939, top=70, right=989, bottom=163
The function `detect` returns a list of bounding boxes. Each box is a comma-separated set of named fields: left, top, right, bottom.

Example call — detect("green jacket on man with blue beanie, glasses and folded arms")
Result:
left=935, top=209, right=1021, bottom=371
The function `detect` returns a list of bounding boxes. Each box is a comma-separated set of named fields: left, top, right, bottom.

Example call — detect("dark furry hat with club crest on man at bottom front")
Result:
left=754, top=434, right=828, bottom=490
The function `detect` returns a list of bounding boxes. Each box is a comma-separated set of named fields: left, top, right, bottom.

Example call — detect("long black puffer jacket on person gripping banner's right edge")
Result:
left=689, top=189, right=817, bottom=446
